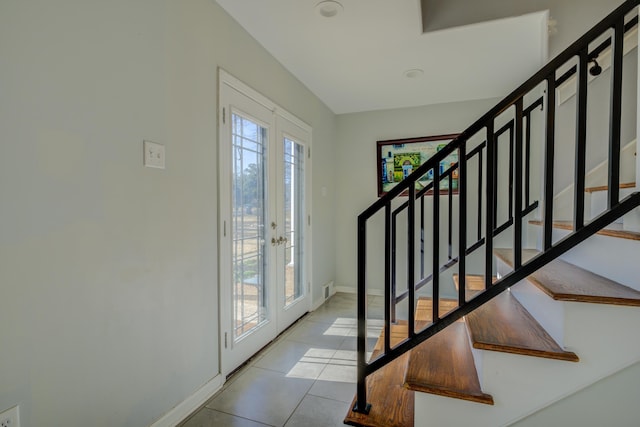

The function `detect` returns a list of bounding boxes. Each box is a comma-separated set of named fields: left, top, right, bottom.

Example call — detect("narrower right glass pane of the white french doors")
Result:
left=284, top=138, right=304, bottom=306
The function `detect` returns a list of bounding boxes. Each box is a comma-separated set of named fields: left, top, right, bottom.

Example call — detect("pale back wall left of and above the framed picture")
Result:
left=334, top=99, right=498, bottom=292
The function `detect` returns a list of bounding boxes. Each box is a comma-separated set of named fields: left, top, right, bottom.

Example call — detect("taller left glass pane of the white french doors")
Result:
left=231, top=114, right=268, bottom=339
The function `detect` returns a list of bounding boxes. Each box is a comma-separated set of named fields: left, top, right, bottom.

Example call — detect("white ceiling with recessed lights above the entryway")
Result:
left=217, top=0, right=547, bottom=114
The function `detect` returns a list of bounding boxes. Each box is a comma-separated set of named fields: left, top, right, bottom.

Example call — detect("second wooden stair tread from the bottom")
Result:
left=405, top=322, right=493, bottom=405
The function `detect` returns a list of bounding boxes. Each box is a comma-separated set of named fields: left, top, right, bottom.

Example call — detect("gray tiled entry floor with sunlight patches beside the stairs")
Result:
left=181, top=293, right=383, bottom=427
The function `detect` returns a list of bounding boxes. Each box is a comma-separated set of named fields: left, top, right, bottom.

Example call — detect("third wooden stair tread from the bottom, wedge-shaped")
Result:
left=466, top=291, right=580, bottom=362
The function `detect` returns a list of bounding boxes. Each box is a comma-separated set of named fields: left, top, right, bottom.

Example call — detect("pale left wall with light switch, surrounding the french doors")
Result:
left=0, top=0, right=336, bottom=427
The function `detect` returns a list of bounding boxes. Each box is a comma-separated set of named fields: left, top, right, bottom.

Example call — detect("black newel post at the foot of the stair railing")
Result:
left=353, top=215, right=370, bottom=414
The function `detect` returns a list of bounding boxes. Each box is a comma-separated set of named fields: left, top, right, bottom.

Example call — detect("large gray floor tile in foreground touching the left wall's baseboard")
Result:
left=206, top=367, right=313, bottom=426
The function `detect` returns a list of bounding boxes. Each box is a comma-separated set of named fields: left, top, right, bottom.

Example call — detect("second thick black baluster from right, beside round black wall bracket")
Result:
left=573, top=48, right=589, bottom=230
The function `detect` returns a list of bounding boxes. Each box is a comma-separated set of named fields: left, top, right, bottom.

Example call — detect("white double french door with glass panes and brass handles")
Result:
left=219, top=72, right=310, bottom=375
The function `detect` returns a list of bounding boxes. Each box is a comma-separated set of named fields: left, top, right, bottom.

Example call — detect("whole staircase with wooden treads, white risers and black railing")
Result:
left=345, top=0, right=640, bottom=427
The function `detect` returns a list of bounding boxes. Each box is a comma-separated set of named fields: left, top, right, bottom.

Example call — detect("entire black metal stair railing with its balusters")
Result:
left=353, top=0, right=640, bottom=413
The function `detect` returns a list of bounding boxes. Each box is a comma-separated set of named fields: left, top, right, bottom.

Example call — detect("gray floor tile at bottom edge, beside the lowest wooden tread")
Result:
left=285, top=395, right=349, bottom=427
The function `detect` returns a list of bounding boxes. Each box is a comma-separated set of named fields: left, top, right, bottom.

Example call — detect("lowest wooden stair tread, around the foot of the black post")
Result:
left=344, top=321, right=414, bottom=427
